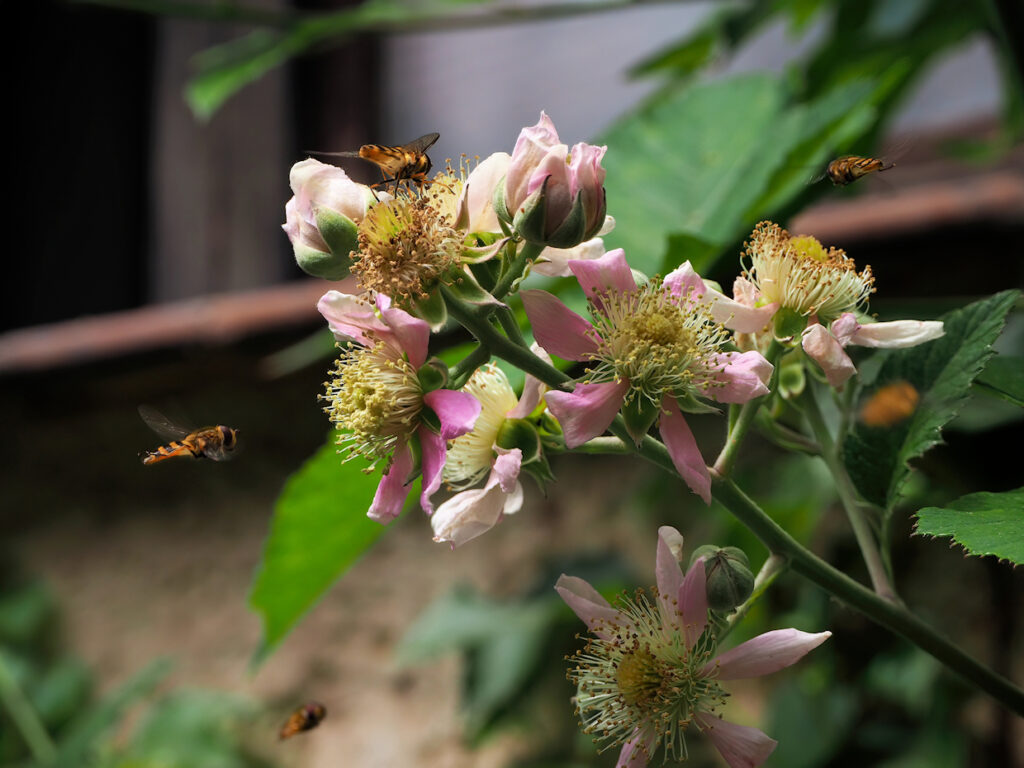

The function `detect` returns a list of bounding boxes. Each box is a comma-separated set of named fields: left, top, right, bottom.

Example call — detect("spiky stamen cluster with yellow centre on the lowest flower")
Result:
left=568, top=590, right=726, bottom=761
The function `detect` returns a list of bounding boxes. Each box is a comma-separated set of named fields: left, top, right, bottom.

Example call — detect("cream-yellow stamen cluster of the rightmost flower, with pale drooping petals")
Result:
left=744, top=221, right=874, bottom=324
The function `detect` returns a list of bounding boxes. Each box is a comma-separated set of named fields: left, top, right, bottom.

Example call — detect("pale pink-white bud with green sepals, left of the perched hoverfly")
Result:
left=282, top=159, right=373, bottom=280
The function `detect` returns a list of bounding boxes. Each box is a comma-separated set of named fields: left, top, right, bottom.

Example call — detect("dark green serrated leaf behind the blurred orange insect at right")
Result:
left=843, top=291, right=1018, bottom=511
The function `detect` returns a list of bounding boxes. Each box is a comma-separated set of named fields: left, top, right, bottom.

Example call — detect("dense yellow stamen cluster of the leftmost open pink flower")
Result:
left=321, top=342, right=423, bottom=469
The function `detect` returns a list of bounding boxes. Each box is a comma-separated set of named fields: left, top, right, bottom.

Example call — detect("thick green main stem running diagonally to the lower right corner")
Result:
left=442, top=289, right=1024, bottom=717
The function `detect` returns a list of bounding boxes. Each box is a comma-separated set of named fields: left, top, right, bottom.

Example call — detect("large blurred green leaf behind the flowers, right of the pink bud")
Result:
left=601, top=74, right=874, bottom=273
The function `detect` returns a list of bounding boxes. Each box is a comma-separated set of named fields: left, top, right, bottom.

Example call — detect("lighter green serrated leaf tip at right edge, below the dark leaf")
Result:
left=914, top=487, right=1024, bottom=565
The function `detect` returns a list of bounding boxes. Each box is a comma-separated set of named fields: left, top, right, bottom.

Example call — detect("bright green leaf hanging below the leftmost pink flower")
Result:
left=249, top=436, right=384, bottom=664
